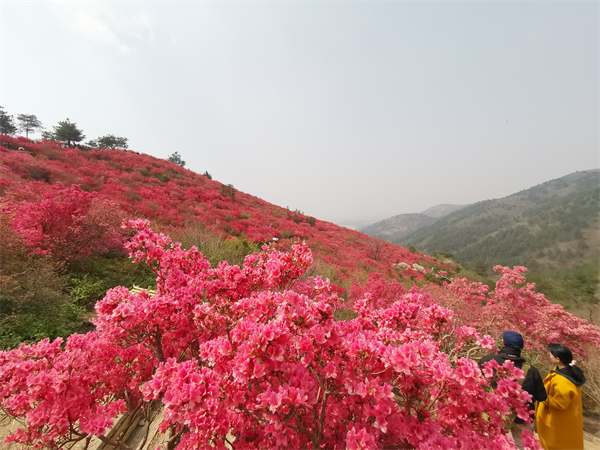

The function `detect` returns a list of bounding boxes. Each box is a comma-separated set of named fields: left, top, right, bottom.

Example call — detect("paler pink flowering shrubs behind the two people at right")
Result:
left=350, top=266, right=600, bottom=406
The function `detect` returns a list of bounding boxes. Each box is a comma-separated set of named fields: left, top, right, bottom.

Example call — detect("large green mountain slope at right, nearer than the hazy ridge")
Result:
left=393, top=169, right=600, bottom=270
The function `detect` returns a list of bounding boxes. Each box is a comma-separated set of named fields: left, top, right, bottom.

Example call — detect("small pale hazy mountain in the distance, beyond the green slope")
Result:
left=360, top=203, right=466, bottom=242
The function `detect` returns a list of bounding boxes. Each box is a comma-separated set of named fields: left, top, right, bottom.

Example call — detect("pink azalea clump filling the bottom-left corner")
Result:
left=0, top=332, right=149, bottom=448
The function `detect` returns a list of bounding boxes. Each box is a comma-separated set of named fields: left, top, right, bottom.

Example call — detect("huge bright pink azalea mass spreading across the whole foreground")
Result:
left=0, top=220, right=556, bottom=450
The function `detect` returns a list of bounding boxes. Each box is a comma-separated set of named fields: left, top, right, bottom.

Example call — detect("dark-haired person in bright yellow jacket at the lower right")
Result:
left=535, top=344, right=586, bottom=450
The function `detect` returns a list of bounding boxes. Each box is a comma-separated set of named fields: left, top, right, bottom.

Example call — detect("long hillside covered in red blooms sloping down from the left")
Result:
left=0, top=135, right=435, bottom=282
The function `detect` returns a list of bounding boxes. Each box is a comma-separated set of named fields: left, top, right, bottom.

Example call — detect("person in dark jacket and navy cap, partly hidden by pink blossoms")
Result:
left=478, top=331, right=547, bottom=449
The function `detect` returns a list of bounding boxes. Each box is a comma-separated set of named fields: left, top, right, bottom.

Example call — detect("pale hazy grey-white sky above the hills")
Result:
left=0, top=0, right=600, bottom=224
